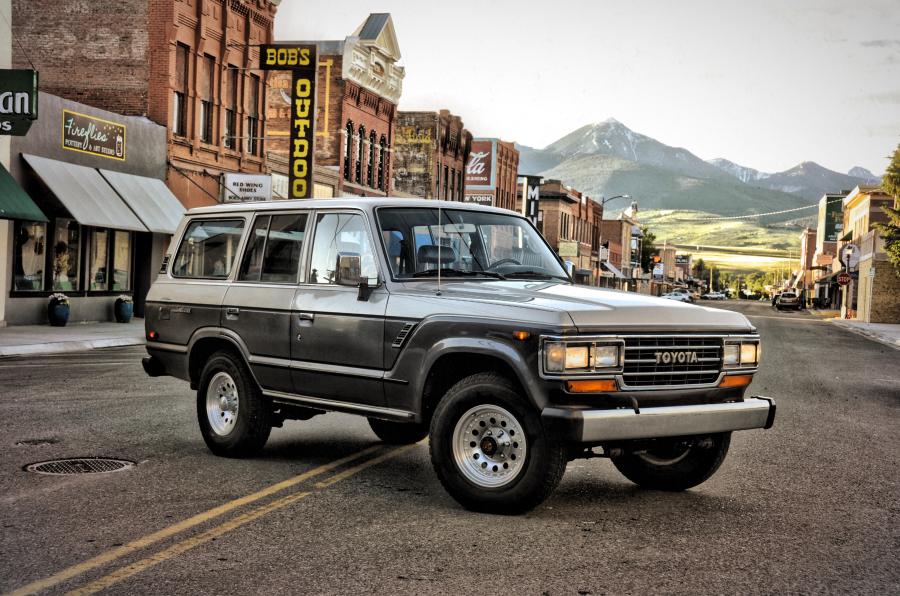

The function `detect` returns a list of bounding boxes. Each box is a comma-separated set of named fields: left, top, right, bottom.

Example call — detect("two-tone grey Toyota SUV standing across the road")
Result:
left=143, top=199, right=775, bottom=514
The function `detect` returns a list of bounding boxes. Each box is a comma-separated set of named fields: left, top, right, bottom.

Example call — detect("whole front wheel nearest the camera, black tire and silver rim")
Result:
left=430, top=373, right=568, bottom=514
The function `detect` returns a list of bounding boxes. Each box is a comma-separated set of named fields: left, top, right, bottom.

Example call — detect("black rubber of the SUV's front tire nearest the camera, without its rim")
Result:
left=430, top=372, right=568, bottom=515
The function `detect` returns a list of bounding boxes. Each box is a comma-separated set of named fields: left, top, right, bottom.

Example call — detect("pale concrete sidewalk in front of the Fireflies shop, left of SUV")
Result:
left=0, top=319, right=144, bottom=358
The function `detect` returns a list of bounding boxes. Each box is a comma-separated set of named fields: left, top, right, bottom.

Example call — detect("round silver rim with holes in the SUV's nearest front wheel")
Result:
left=452, top=404, right=528, bottom=488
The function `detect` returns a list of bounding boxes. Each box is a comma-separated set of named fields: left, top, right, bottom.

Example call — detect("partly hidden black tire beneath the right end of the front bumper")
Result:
left=612, top=433, right=731, bottom=491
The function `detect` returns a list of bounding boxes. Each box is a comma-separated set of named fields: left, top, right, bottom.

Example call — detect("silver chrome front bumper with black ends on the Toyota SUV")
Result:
left=541, top=396, right=775, bottom=443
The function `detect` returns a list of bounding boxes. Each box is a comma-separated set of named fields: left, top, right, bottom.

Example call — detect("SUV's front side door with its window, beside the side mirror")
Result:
left=291, top=210, right=388, bottom=406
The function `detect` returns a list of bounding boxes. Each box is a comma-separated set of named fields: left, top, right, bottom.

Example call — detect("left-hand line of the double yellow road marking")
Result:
left=9, top=445, right=381, bottom=596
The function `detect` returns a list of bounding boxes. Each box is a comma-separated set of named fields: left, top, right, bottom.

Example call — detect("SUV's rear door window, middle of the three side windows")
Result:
left=238, top=213, right=307, bottom=283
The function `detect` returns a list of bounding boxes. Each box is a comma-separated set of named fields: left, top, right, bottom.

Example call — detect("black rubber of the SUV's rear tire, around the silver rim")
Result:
left=197, top=351, right=272, bottom=457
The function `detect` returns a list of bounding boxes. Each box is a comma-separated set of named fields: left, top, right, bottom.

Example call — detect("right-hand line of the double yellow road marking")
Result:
left=67, top=445, right=414, bottom=596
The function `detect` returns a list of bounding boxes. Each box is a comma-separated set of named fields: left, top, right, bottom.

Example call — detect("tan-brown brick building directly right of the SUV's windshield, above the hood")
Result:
left=519, top=180, right=603, bottom=285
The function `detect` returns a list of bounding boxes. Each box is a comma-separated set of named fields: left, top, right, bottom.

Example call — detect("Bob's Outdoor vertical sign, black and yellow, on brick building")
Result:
left=259, top=44, right=318, bottom=199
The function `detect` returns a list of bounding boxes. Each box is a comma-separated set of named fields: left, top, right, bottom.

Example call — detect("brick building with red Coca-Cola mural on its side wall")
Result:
left=463, top=139, right=519, bottom=211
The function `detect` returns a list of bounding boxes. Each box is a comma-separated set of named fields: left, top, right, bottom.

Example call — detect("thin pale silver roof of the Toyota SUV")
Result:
left=187, top=197, right=521, bottom=217
